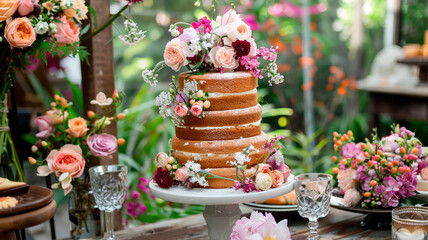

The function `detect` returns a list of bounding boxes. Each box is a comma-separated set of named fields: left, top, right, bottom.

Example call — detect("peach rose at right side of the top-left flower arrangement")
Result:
left=52, top=16, right=80, bottom=45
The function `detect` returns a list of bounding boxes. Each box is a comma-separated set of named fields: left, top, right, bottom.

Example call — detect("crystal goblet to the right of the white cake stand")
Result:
left=294, top=173, right=332, bottom=240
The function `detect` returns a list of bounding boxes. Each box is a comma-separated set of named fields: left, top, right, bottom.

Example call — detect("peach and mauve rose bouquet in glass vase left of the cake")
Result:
left=29, top=92, right=125, bottom=195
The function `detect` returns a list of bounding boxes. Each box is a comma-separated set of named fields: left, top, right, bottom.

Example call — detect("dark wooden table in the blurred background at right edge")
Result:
left=358, top=84, right=428, bottom=130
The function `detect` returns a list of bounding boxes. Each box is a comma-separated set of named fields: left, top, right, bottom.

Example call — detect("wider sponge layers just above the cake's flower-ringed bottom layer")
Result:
left=171, top=132, right=267, bottom=168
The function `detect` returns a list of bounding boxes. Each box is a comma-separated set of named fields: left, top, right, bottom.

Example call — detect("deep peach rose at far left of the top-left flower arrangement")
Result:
left=4, top=17, right=36, bottom=48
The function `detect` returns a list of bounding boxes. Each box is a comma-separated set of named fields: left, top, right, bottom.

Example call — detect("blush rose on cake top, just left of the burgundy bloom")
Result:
left=209, top=47, right=239, bottom=71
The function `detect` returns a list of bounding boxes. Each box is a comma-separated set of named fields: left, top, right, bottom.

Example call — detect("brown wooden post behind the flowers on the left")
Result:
left=82, top=0, right=118, bottom=166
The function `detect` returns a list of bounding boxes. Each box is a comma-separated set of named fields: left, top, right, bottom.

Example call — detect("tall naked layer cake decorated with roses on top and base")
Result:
left=142, top=9, right=290, bottom=192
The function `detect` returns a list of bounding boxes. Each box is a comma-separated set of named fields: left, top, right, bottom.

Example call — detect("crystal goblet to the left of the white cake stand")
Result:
left=89, top=165, right=128, bottom=240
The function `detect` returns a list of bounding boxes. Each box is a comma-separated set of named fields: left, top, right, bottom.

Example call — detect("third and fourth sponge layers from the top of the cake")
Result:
left=175, top=105, right=262, bottom=140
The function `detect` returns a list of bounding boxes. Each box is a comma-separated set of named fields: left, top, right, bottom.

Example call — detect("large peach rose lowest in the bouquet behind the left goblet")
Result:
left=46, top=144, right=85, bottom=178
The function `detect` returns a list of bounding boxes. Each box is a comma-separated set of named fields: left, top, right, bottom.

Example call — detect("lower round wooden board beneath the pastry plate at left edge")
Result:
left=0, top=200, right=56, bottom=232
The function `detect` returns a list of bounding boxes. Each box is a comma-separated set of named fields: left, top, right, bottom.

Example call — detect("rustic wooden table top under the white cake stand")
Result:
left=116, top=207, right=391, bottom=240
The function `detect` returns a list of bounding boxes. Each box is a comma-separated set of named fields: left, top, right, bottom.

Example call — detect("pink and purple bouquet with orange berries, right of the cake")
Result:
left=332, top=125, right=426, bottom=208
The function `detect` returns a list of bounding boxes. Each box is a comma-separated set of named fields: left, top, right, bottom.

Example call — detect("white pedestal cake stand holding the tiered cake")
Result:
left=149, top=174, right=294, bottom=240
